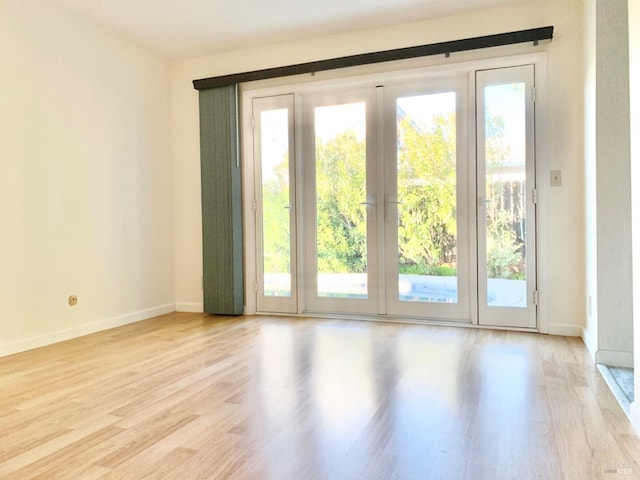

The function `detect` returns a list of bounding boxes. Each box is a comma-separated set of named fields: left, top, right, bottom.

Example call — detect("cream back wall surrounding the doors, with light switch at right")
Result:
left=171, top=0, right=586, bottom=335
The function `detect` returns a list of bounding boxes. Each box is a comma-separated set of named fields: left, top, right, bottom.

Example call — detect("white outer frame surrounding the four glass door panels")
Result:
left=240, top=48, right=549, bottom=333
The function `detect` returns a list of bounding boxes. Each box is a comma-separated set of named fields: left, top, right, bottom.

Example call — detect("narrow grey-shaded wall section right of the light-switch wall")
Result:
left=596, top=0, right=633, bottom=367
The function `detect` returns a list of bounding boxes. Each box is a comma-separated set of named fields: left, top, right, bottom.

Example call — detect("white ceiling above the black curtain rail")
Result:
left=50, top=0, right=520, bottom=58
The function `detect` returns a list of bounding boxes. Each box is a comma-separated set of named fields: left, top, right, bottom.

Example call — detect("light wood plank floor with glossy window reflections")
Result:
left=0, top=314, right=640, bottom=480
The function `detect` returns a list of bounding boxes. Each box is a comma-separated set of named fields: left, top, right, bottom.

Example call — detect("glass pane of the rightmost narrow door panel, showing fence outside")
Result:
left=484, top=82, right=527, bottom=308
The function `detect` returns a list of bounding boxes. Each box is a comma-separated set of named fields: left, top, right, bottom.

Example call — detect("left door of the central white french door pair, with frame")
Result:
left=301, top=89, right=380, bottom=314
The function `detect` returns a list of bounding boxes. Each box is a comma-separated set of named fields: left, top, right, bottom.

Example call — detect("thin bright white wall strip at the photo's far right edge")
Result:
left=629, top=0, right=640, bottom=433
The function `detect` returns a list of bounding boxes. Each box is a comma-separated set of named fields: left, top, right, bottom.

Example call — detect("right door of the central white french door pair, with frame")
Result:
left=383, top=77, right=471, bottom=320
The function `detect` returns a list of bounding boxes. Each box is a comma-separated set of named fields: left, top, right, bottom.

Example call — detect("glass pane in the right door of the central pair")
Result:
left=392, top=92, right=458, bottom=303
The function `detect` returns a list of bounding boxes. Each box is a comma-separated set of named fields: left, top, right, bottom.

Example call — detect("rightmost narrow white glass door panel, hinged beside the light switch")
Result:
left=476, top=65, right=538, bottom=328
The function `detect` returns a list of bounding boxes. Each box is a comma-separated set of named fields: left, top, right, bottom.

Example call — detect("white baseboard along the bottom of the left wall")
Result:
left=0, top=303, right=176, bottom=357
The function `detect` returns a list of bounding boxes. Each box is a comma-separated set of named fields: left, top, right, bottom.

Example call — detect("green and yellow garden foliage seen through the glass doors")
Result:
left=263, top=105, right=523, bottom=279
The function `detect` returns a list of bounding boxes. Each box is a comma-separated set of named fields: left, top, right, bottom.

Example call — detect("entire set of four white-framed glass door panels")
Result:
left=252, top=65, right=537, bottom=328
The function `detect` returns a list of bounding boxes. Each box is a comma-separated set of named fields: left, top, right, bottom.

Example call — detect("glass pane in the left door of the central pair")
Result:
left=314, top=102, right=368, bottom=298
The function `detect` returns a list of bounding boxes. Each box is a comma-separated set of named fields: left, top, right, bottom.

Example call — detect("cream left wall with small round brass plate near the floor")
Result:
left=0, top=0, right=174, bottom=355
